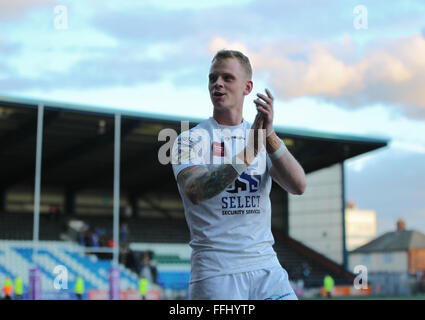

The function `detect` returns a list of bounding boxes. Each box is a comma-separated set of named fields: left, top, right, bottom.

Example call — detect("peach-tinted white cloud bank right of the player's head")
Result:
left=209, top=34, right=425, bottom=118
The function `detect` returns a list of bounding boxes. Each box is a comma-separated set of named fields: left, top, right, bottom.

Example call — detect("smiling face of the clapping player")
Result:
left=208, top=58, right=252, bottom=109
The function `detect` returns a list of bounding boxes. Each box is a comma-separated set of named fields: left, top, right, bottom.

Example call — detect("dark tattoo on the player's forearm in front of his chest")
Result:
left=178, top=164, right=239, bottom=204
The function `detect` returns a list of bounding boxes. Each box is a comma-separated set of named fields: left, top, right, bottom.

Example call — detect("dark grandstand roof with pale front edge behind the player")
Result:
left=0, top=96, right=388, bottom=195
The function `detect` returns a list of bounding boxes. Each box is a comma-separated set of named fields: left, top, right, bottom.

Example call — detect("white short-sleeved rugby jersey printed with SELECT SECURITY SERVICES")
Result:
left=173, top=117, right=279, bottom=282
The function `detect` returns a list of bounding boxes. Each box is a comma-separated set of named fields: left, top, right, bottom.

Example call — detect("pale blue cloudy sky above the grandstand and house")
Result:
left=0, top=0, right=425, bottom=234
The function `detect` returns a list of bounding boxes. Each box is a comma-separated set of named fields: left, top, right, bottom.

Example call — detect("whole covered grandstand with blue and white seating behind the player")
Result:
left=0, top=96, right=388, bottom=299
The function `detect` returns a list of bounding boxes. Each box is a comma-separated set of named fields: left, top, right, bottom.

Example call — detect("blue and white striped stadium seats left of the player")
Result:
left=0, top=240, right=190, bottom=299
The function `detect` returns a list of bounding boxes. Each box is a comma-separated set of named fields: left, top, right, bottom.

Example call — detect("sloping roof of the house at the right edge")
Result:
left=351, top=230, right=425, bottom=253
